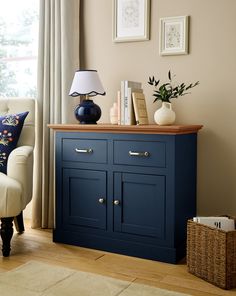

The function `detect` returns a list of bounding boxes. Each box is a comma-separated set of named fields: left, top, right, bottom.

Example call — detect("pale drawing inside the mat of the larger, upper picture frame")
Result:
left=122, top=0, right=140, bottom=28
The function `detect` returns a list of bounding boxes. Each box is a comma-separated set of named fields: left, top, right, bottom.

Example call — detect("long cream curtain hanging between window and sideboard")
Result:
left=32, top=0, right=80, bottom=228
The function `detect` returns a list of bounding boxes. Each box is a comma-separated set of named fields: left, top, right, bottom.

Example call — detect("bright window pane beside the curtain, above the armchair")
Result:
left=0, top=0, right=39, bottom=97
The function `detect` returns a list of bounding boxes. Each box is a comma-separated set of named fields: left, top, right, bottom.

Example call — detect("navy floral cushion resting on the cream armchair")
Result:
left=0, top=112, right=29, bottom=174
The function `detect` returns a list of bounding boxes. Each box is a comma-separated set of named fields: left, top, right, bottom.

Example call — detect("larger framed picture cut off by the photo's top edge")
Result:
left=113, top=0, right=150, bottom=42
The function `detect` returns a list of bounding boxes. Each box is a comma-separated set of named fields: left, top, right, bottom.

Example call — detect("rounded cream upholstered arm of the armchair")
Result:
left=7, top=146, right=34, bottom=207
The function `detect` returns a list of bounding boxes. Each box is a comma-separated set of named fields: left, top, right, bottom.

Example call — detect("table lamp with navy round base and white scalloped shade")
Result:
left=69, top=70, right=106, bottom=124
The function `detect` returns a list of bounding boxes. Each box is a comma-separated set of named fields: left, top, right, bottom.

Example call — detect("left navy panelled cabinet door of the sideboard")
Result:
left=63, top=169, right=106, bottom=229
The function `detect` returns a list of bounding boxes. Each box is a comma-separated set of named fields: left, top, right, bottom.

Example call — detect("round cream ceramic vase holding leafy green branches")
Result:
left=154, top=102, right=175, bottom=125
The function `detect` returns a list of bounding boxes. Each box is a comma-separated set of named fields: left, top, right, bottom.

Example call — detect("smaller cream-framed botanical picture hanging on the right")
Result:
left=159, top=16, right=189, bottom=55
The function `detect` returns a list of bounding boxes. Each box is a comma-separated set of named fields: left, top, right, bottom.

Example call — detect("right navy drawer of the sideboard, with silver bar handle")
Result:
left=114, top=140, right=166, bottom=167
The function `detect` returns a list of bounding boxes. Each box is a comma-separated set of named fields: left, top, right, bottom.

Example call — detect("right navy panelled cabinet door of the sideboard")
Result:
left=113, top=173, right=165, bottom=238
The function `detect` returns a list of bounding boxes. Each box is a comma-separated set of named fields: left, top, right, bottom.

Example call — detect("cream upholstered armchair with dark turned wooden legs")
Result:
left=0, top=98, right=35, bottom=257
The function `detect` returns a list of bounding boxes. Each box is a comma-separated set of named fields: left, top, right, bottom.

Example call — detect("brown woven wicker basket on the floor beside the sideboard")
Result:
left=187, top=220, right=236, bottom=289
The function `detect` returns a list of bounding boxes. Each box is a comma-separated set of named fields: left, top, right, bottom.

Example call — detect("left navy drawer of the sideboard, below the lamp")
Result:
left=62, top=138, right=107, bottom=163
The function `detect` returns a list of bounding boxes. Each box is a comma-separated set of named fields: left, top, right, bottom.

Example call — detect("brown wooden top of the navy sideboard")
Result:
left=48, top=123, right=203, bottom=135
